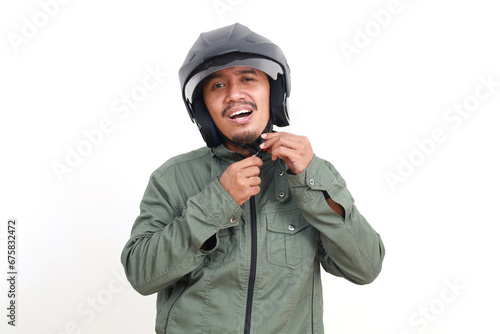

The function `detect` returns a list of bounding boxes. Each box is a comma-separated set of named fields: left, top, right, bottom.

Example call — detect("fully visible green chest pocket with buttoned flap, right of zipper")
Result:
left=266, top=210, right=317, bottom=269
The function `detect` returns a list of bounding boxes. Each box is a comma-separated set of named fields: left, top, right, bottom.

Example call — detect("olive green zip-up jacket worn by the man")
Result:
left=121, top=145, right=385, bottom=334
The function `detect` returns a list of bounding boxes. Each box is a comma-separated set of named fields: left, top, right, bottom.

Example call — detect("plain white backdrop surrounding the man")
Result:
left=0, top=0, right=500, bottom=334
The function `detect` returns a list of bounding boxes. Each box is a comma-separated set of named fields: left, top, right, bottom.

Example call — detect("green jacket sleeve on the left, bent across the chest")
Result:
left=121, top=172, right=243, bottom=295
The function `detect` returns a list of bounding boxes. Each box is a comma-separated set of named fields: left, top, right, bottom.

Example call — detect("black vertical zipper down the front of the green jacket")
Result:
left=243, top=196, right=257, bottom=334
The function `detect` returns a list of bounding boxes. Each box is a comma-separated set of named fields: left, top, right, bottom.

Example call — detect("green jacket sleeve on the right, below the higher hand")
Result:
left=288, top=156, right=385, bottom=284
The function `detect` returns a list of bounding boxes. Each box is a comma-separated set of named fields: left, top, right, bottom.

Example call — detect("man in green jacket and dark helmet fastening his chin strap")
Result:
left=121, top=24, right=385, bottom=334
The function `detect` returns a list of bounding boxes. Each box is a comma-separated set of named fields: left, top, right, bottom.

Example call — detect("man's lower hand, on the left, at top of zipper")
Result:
left=219, top=156, right=263, bottom=206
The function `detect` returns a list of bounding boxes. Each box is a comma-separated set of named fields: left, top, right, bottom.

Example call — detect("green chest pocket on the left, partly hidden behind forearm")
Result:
left=205, top=226, right=241, bottom=268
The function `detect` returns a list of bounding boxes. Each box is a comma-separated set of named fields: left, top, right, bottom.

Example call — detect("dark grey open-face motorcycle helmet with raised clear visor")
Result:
left=179, top=23, right=290, bottom=147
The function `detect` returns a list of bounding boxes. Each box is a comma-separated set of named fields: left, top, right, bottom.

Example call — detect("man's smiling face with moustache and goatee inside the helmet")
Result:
left=203, top=67, right=270, bottom=150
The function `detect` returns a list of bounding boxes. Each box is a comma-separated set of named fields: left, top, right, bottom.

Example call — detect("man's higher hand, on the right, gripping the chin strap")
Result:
left=260, top=132, right=314, bottom=174
